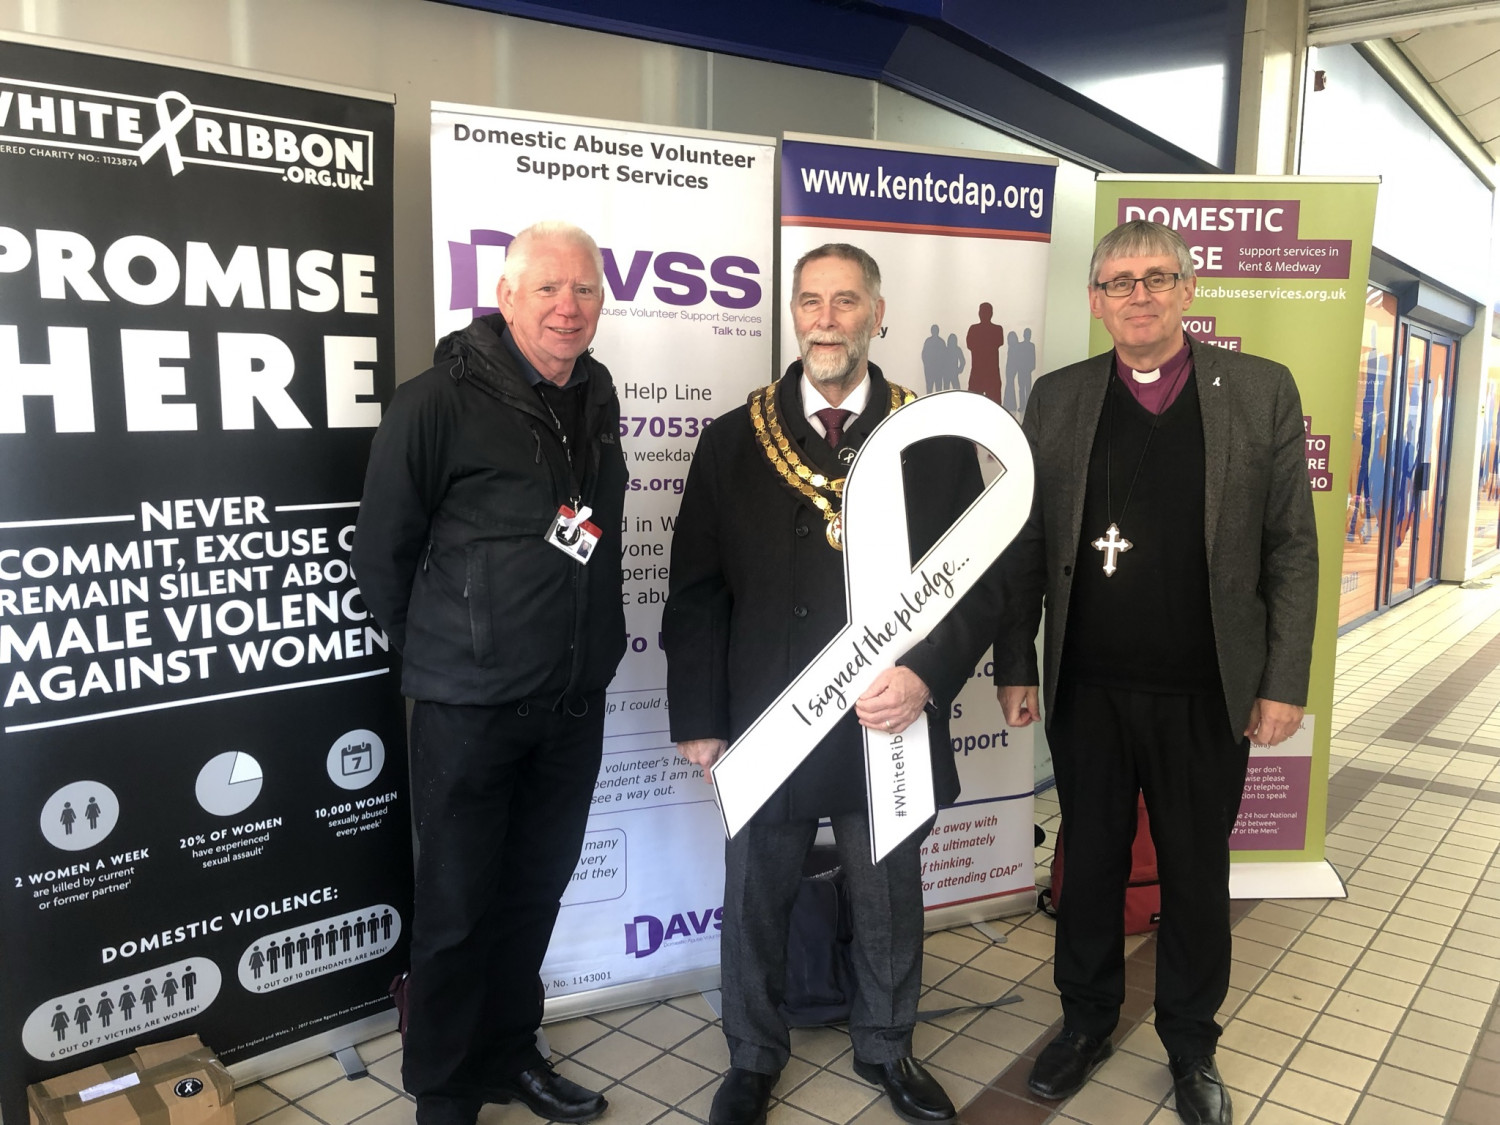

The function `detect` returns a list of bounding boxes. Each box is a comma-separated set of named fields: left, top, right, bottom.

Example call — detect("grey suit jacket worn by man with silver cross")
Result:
left=995, top=341, right=1319, bottom=735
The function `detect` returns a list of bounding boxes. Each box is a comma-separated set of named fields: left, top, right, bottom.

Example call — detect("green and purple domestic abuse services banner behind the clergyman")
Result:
left=1091, top=176, right=1377, bottom=861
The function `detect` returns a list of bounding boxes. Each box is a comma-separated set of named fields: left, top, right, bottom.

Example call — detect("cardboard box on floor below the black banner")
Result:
left=26, top=1035, right=234, bottom=1125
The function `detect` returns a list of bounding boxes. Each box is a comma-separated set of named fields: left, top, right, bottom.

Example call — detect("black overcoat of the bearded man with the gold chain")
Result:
left=663, top=363, right=996, bottom=822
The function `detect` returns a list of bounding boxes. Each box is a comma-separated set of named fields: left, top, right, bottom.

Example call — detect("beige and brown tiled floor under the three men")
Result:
left=239, top=581, right=1500, bottom=1125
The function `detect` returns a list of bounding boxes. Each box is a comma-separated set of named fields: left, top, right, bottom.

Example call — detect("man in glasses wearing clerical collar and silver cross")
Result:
left=995, top=222, right=1317, bottom=1125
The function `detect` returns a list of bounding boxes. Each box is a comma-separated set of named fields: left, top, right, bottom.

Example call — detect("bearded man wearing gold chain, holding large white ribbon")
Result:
left=663, top=245, right=993, bottom=1125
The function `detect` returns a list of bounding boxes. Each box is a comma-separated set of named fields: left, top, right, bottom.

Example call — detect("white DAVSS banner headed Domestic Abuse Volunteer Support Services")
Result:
left=432, top=105, right=776, bottom=1013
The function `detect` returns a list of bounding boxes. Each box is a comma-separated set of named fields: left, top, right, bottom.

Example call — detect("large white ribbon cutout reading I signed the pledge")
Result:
left=713, top=392, right=1035, bottom=863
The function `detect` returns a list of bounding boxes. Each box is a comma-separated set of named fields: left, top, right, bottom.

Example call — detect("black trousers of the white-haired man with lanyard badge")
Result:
left=402, top=692, right=605, bottom=1098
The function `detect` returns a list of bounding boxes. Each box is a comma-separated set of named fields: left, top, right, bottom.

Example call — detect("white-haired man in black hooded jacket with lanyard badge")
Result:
left=354, top=222, right=627, bottom=1125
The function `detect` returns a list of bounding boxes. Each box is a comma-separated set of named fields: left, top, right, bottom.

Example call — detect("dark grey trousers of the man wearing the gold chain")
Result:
left=720, top=813, right=932, bottom=1074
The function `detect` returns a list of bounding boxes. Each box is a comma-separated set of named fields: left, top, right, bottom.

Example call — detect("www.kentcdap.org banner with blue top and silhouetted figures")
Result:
left=782, top=134, right=1058, bottom=924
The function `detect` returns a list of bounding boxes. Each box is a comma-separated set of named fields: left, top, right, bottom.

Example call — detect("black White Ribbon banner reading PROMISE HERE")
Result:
left=0, top=42, right=411, bottom=1122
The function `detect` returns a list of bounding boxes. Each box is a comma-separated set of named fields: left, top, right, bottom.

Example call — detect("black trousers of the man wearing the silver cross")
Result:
left=1047, top=681, right=1250, bottom=1056
